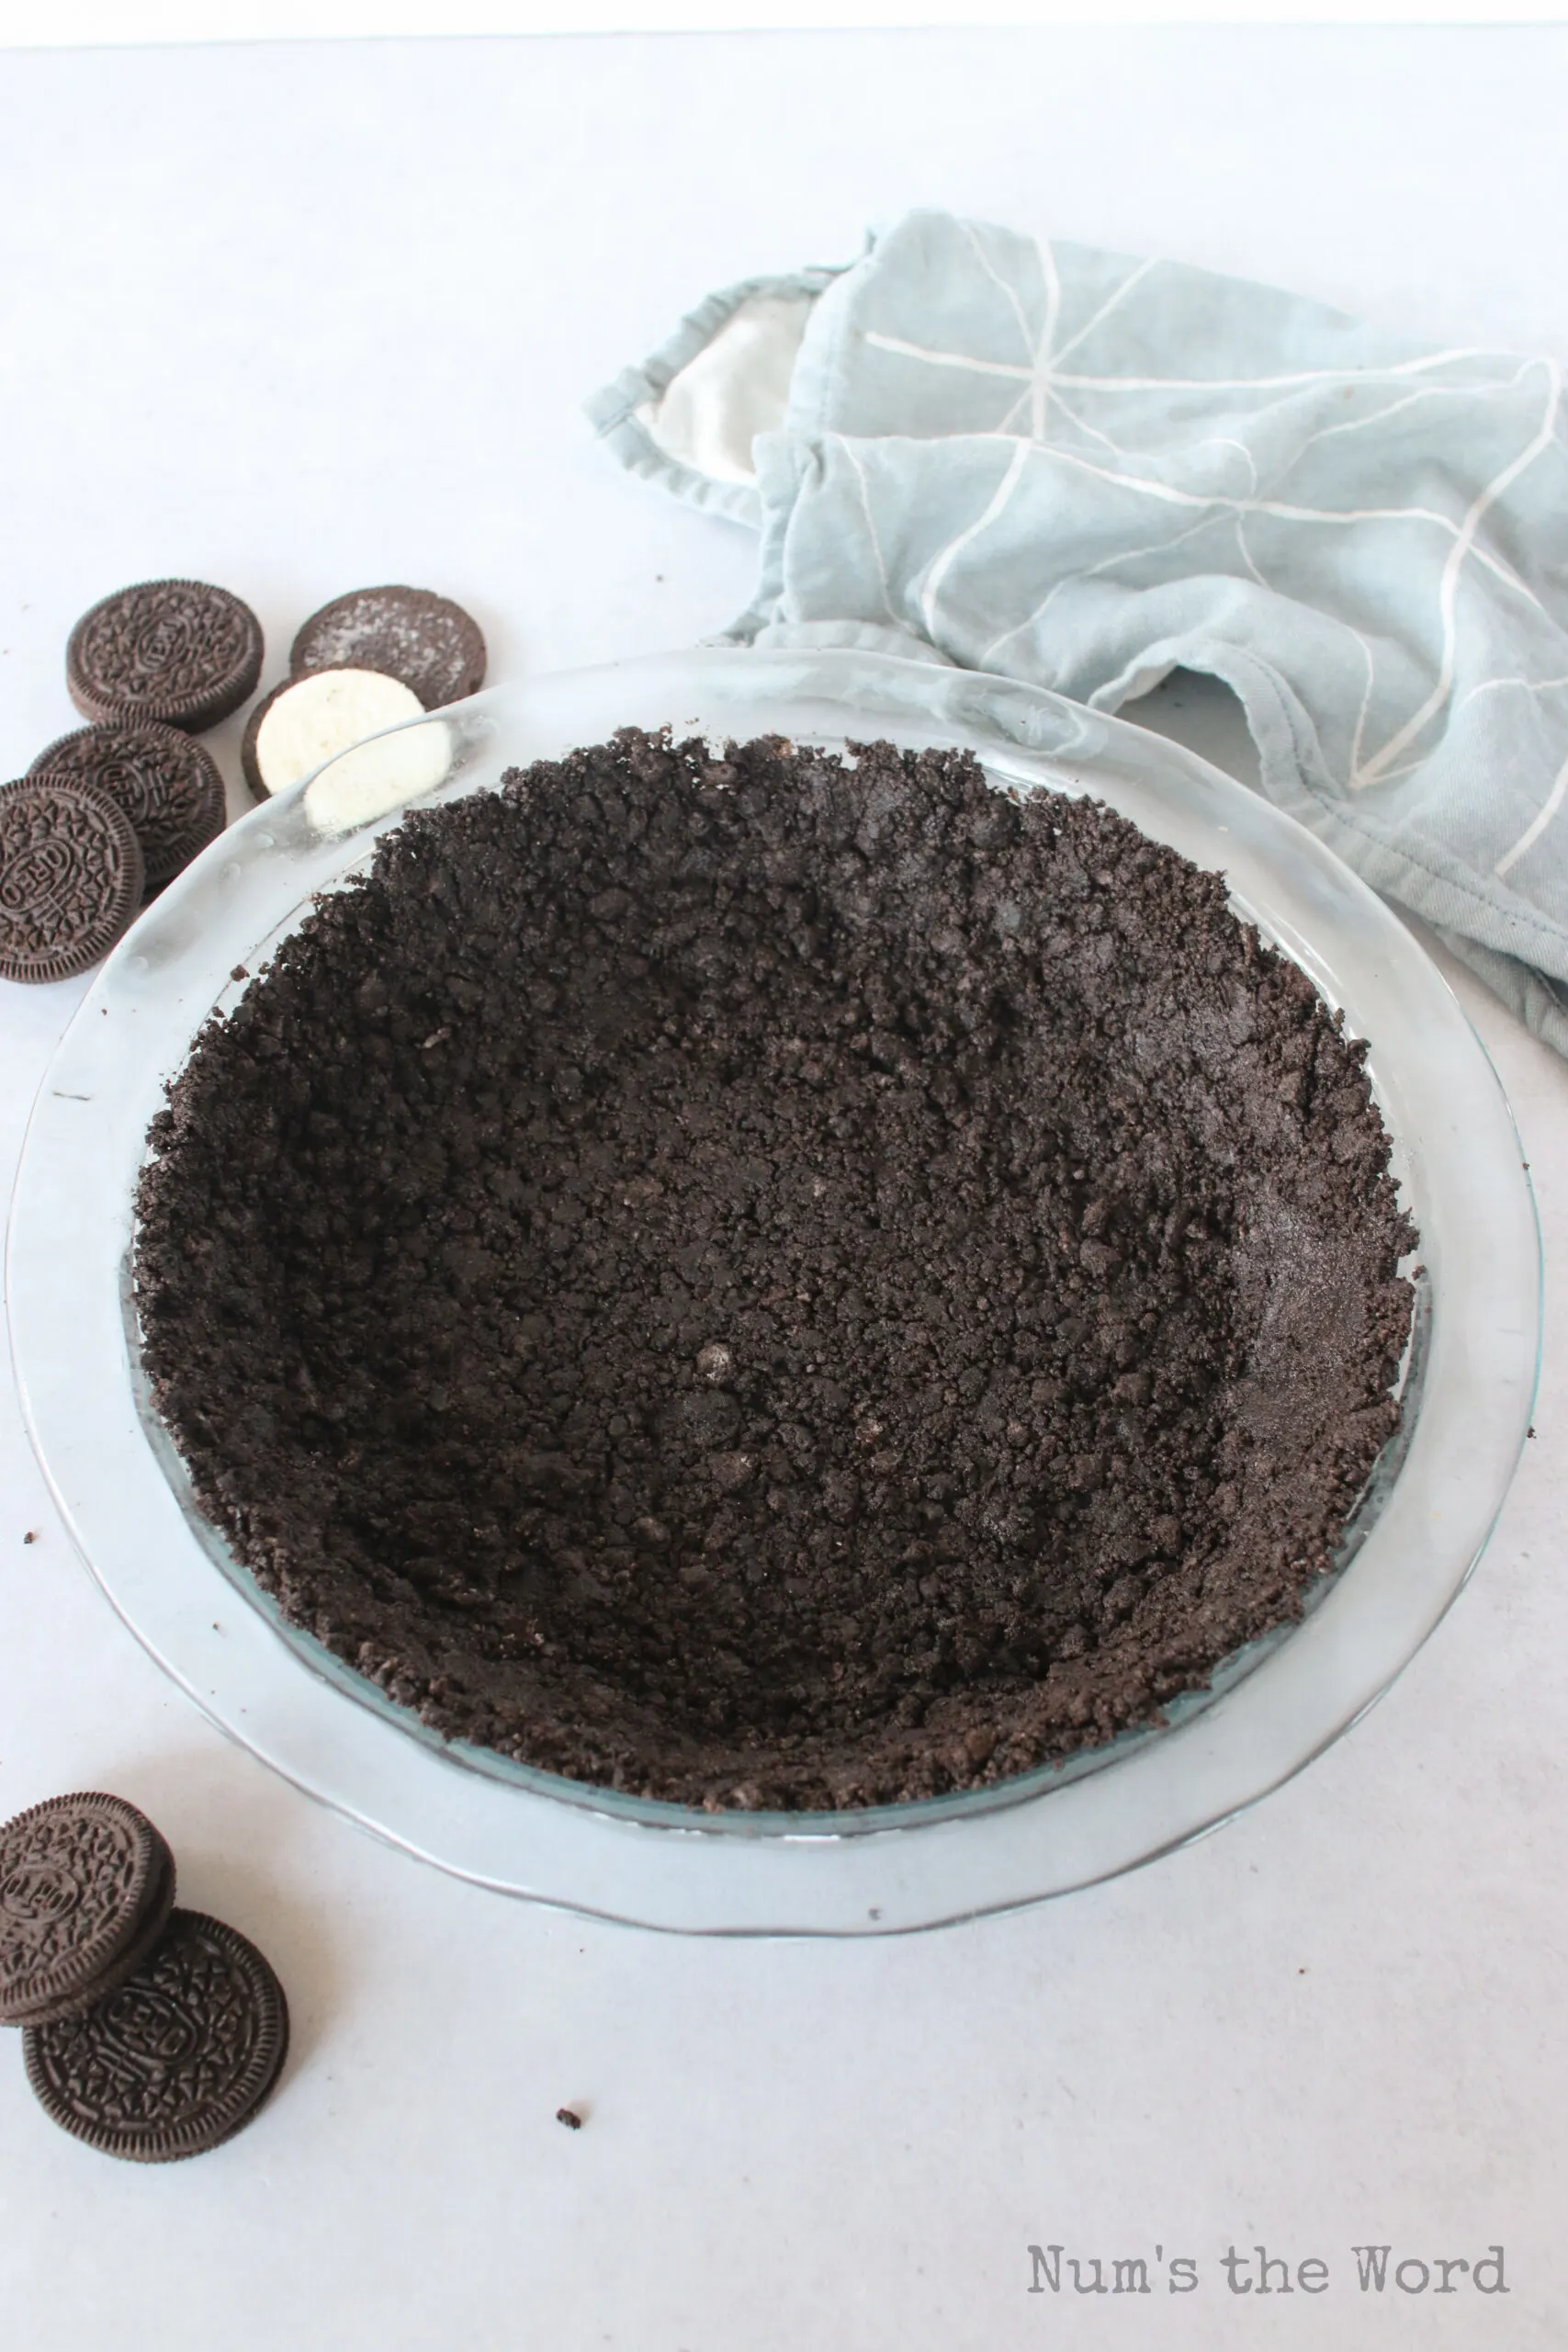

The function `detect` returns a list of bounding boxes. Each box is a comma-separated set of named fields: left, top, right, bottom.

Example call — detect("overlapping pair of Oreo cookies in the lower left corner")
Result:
left=0, top=1792, right=289, bottom=2164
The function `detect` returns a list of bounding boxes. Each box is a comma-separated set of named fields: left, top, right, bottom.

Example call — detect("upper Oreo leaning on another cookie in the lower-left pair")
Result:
left=0, top=1790, right=174, bottom=2025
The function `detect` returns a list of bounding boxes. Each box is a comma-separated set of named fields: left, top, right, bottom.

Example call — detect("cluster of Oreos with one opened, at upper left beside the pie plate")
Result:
left=0, top=581, right=484, bottom=981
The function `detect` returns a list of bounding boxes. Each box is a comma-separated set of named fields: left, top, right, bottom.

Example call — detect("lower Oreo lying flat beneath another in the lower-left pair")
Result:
left=24, top=1910, right=289, bottom=2164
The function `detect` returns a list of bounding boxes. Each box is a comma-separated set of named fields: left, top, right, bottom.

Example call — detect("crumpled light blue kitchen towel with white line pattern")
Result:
left=588, top=211, right=1568, bottom=1054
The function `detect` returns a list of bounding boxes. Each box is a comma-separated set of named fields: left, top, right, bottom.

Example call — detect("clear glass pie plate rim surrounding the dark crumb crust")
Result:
left=7, top=651, right=1540, bottom=1936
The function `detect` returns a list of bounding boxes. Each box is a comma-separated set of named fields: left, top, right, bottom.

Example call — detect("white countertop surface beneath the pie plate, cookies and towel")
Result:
left=0, top=28, right=1568, bottom=2352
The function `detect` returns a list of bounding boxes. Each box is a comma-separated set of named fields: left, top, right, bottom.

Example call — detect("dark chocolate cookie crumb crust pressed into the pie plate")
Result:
left=136, top=731, right=1416, bottom=1811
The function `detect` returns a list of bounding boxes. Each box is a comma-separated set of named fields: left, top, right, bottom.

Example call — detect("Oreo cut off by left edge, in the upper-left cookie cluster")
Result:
left=0, top=774, right=143, bottom=981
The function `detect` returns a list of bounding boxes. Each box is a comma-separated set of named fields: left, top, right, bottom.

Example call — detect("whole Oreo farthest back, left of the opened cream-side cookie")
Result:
left=66, top=581, right=261, bottom=731
